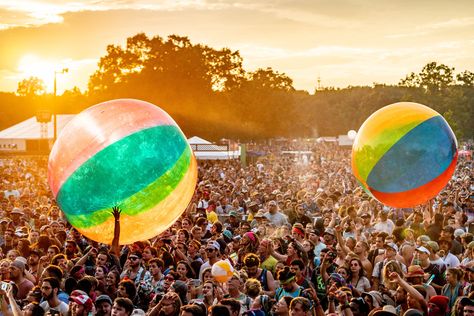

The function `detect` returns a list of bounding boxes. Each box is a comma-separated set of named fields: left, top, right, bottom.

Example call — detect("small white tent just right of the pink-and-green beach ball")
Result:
left=188, top=136, right=240, bottom=160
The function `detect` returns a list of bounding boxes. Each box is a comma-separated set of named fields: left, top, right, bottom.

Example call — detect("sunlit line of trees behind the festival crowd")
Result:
left=0, top=33, right=474, bottom=141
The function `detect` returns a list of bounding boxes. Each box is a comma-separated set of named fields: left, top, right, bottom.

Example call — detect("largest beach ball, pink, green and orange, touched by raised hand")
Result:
left=48, top=99, right=197, bottom=244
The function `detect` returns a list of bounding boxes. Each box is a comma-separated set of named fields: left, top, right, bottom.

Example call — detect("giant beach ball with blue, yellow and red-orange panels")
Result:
left=352, top=102, right=458, bottom=208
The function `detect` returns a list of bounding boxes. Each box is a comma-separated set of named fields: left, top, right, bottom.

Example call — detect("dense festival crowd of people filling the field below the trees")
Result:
left=0, top=140, right=474, bottom=316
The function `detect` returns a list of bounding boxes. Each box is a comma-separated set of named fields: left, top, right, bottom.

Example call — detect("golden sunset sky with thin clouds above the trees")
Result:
left=0, top=0, right=474, bottom=93
